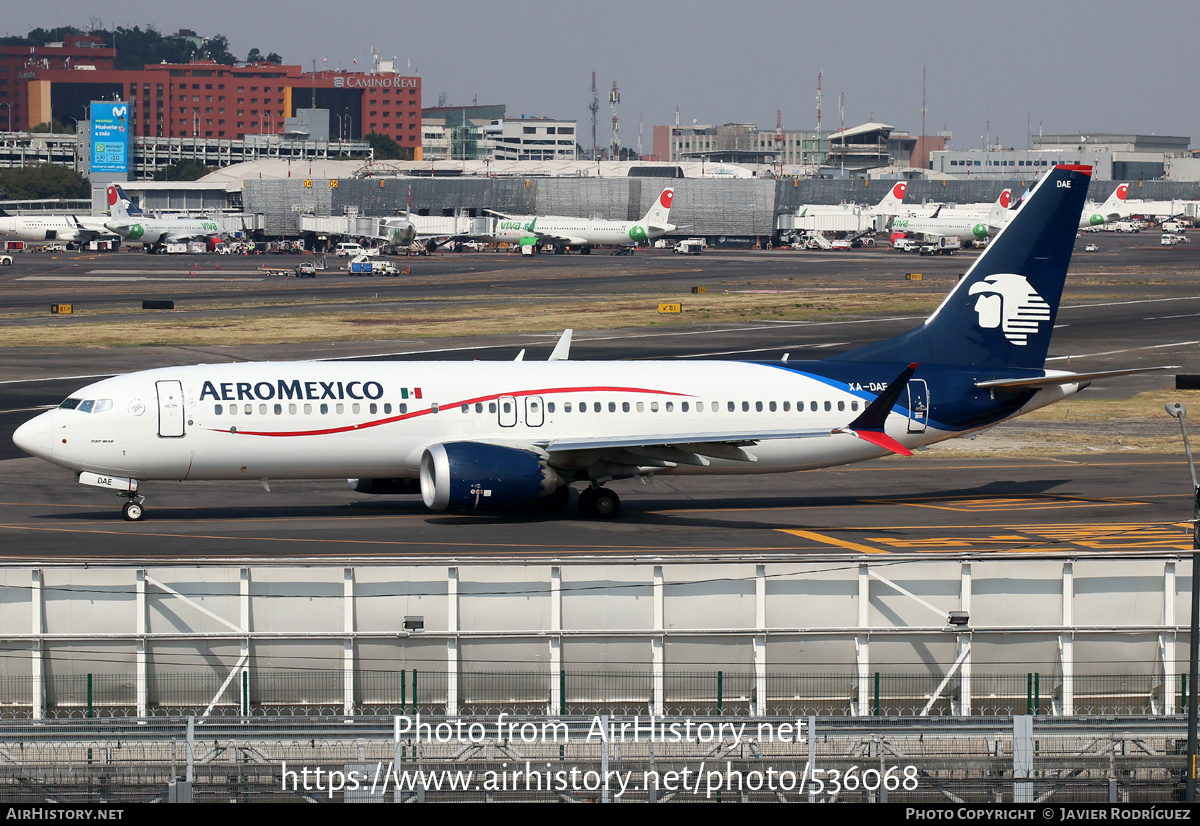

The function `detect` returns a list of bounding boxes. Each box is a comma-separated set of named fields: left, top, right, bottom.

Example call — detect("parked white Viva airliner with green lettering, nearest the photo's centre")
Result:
left=487, top=187, right=676, bottom=255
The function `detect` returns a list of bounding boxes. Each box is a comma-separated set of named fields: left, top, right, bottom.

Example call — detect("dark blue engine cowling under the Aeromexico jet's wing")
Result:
left=421, top=442, right=563, bottom=510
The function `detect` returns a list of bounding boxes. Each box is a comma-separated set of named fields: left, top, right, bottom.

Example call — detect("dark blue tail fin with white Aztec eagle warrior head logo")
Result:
left=833, top=164, right=1092, bottom=370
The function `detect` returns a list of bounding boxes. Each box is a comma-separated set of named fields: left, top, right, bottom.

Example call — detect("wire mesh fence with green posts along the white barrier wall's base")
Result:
left=0, top=669, right=1187, bottom=720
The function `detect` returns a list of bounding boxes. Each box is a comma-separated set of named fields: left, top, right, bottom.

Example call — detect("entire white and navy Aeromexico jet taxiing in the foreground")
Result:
left=13, top=166, right=1161, bottom=520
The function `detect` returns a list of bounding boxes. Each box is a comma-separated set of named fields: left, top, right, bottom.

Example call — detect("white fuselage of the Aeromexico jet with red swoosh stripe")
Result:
left=14, top=361, right=1073, bottom=480
